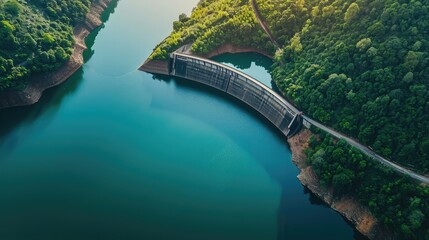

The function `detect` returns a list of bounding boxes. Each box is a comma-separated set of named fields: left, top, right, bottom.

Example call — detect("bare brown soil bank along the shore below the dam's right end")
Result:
left=288, top=129, right=393, bottom=239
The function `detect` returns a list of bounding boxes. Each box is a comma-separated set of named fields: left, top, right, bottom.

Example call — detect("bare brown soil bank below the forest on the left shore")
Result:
left=0, top=0, right=112, bottom=109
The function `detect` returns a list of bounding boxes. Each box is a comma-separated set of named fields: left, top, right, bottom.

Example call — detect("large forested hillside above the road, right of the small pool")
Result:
left=257, top=0, right=429, bottom=173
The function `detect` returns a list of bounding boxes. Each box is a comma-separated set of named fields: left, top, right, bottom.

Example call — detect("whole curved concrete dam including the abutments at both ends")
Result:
left=140, top=52, right=303, bottom=137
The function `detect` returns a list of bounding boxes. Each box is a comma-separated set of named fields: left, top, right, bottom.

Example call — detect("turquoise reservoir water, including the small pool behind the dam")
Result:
left=0, top=0, right=364, bottom=240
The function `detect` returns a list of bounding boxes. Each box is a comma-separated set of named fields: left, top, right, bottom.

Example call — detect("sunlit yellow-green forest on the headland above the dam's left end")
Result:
left=150, top=0, right=275, bottom=59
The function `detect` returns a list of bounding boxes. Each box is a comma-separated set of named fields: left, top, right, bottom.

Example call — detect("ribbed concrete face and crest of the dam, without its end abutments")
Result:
left=171, top=55, right=295, bottom=136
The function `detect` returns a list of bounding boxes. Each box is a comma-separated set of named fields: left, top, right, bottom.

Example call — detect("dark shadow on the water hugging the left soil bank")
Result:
left=0, top=0, right=118, bottom=156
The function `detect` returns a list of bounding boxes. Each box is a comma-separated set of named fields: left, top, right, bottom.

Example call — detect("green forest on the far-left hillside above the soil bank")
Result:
left=0, top=0, right=91, bottom=90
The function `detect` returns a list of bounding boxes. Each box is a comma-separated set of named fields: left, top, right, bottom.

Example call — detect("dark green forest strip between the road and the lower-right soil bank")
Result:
left=306, top=127, right=429, bottom=240
